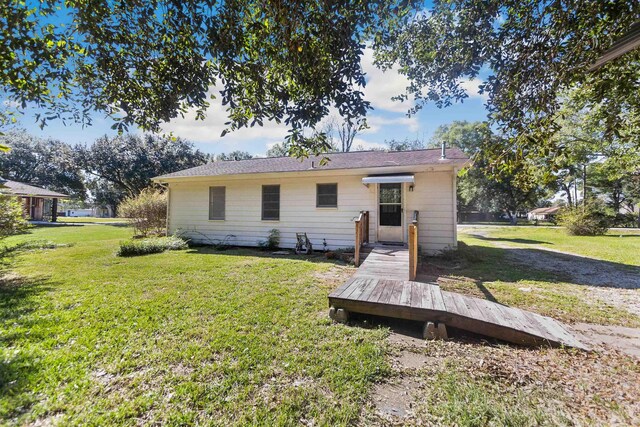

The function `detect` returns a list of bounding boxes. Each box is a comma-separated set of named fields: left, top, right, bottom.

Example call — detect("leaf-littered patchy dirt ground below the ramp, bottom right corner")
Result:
left=364, top=325, right=640, bottom=425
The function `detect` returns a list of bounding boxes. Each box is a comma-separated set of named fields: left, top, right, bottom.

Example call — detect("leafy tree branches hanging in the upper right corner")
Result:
left=377, top=0, right=640, bottom=170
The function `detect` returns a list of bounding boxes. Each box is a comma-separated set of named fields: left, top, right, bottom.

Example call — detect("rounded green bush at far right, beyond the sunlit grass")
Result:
left=557, top=201, right=610, bottom=236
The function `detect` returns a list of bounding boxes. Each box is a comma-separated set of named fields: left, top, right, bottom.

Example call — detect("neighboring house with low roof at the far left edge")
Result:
left=0, top=179, right=69, bottom=222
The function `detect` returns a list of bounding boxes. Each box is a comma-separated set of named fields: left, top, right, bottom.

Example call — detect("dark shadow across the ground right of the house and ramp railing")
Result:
left=421, top=242, right=640, bottom=290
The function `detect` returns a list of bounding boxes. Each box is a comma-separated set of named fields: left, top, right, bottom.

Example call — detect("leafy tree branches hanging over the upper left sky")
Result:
left=0, top=0, right=408, bottom=154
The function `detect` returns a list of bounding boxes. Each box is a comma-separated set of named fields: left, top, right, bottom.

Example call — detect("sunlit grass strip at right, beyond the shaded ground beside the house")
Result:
left=461, top=227, right=640, bottom=266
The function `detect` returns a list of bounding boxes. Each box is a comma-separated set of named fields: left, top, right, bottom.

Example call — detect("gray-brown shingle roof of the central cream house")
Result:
left=153, top=148, right=469, bottom=180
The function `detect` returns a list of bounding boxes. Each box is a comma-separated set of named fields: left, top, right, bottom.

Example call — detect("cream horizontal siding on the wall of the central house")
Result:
left=169, top=171, right=455, bottom=253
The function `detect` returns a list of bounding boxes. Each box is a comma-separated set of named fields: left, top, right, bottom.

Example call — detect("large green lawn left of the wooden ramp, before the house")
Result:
left=0, top=225, right=389, bottom=425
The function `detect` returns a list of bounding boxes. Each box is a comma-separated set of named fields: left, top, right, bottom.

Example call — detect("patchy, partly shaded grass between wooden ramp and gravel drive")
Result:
left=423, top=234, right=640, bottom=327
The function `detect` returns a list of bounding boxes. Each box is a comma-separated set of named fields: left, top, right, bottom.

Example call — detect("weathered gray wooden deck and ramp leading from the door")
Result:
left=329, top=247, right=586, bottom=349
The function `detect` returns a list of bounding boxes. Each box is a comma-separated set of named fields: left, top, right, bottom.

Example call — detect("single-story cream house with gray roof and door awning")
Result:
left=153, top=149, right=469, bottom=253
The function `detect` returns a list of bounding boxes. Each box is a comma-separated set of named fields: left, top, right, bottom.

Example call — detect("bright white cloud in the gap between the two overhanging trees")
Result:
left=362, top=48, right=413, bottom=113
